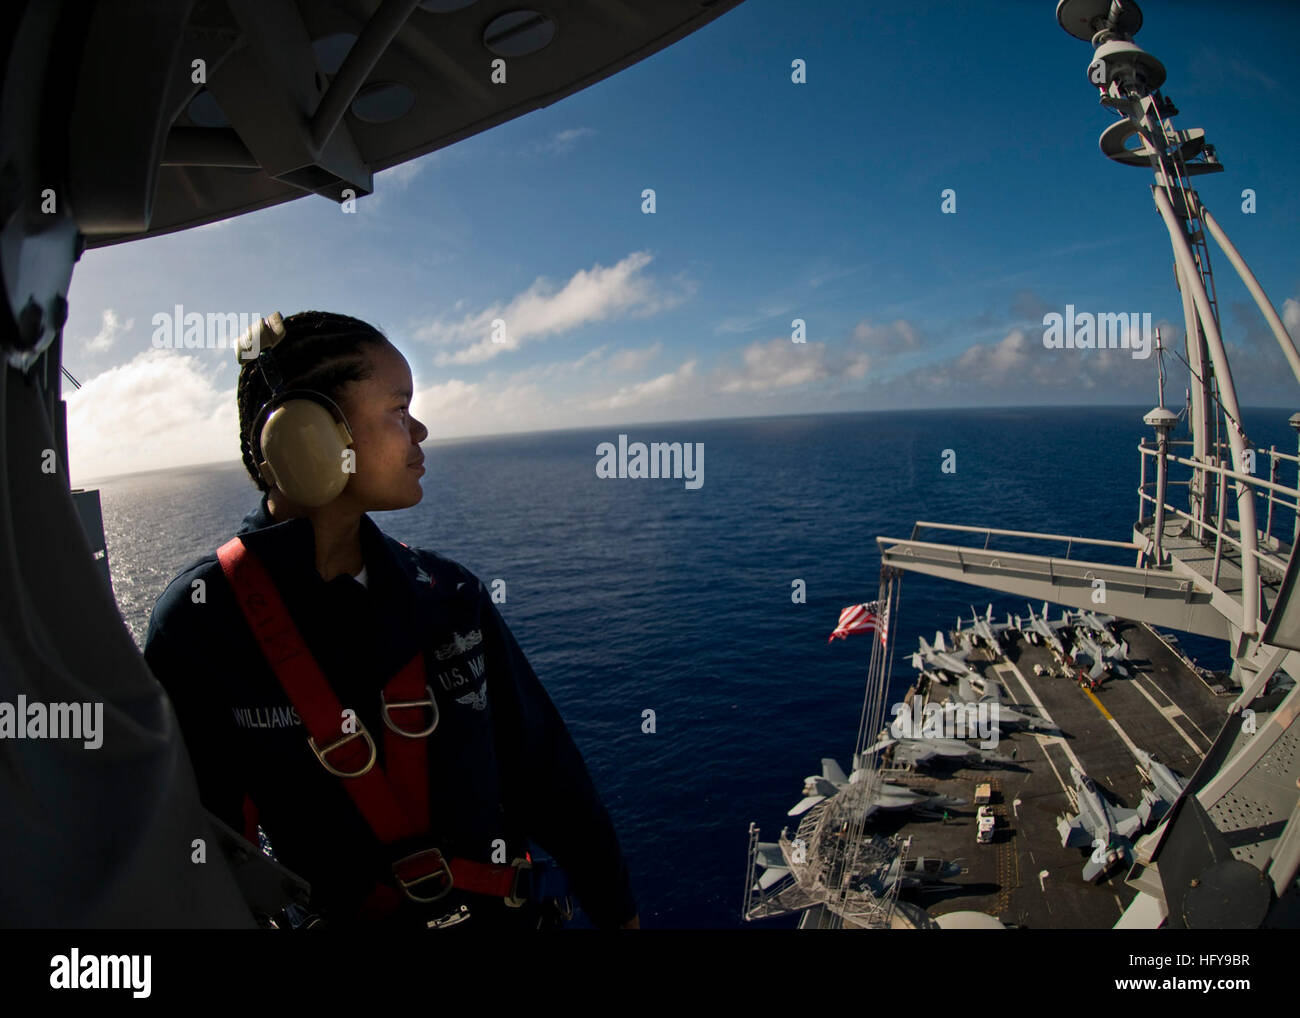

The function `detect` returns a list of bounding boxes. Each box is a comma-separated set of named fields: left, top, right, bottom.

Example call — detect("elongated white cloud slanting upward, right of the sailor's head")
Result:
left=415, top=251, right=694, bottom=367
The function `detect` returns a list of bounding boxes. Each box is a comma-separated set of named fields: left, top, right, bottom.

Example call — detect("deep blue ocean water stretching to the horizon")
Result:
left=88, top=407, right=1295, bottom=927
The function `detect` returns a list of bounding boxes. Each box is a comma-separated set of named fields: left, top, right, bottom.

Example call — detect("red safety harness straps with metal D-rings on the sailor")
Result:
left=217, top=537, right=532, bottom=918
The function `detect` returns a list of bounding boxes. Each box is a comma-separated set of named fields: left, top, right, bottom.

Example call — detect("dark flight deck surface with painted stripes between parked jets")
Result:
left=801, top=620, right=1239, bottom=928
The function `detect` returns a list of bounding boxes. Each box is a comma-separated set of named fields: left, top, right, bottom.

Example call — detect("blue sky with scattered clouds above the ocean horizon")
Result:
left=64, top=0, right=1300, bottom=478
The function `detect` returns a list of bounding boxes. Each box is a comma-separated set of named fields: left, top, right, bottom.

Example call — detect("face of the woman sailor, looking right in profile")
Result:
left=342, top=343, right=429, bottom=512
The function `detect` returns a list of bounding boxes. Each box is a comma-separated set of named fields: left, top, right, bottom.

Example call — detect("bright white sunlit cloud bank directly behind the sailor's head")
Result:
left=66, top=350, right=239, bottom=477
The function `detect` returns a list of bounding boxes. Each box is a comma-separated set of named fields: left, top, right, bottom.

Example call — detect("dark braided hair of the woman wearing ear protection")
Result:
left=235, top=311, right=389, bottom=491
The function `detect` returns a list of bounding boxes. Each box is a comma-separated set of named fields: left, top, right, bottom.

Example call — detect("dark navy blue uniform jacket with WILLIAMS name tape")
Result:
left=144, top=497, right=637, bottom=928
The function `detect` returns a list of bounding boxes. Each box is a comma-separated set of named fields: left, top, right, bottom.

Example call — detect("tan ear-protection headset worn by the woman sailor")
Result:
left=235, top=311, right=352, bottom=508
